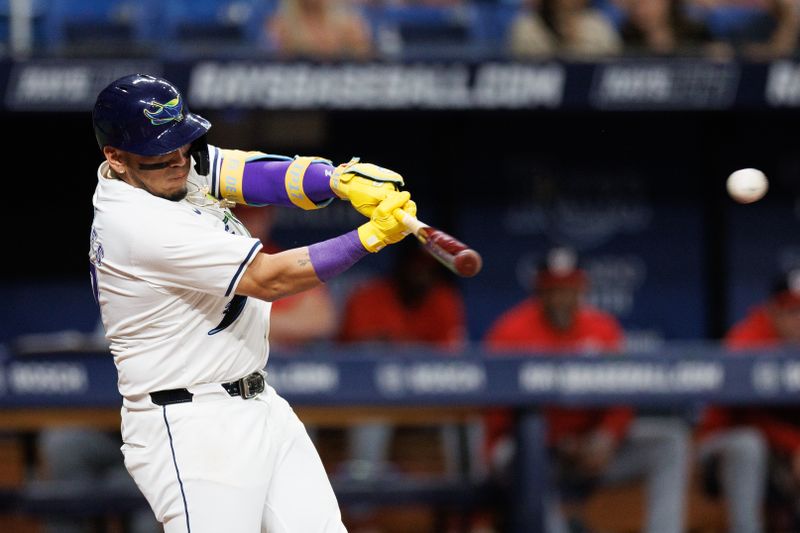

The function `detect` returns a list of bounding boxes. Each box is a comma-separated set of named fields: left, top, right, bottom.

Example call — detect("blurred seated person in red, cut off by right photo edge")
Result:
left=700, top=269, right=800, bottom=531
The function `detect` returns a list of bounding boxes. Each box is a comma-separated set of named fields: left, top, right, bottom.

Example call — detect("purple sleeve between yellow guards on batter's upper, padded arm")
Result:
left=242, top=161, right=334, bottom=207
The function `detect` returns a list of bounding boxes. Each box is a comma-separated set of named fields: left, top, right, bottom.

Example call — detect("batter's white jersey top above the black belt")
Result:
left=90, top=147, right=270, bottom=405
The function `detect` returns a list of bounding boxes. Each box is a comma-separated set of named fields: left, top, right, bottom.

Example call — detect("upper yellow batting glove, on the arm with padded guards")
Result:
left=330, top=157, right=404, bottom=217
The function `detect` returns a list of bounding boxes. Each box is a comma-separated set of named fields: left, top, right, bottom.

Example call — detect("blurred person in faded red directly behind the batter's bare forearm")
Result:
left=233, top=205, right=337, bottom=350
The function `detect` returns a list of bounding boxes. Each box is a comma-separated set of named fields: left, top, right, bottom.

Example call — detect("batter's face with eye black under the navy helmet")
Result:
left=112, top=144, right=191, bottom=202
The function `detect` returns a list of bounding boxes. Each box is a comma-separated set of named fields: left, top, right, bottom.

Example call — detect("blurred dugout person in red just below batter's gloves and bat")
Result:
left=339, top=241, right=466, bottom=476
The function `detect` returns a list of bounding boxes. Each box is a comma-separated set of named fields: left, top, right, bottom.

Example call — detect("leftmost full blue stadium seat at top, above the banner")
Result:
left=44, top=0, right=157, bottom=55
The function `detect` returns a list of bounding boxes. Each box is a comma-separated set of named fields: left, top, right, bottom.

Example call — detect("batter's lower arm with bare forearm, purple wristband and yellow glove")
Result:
left=236, top=191, right=416, bottom=302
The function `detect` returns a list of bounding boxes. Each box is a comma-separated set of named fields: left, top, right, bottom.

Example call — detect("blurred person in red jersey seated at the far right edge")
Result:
left=699, top=269, right=800, bottom=531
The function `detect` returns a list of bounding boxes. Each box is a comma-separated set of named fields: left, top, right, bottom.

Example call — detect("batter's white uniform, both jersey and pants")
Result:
left=90, top=147, right=345, bottom=533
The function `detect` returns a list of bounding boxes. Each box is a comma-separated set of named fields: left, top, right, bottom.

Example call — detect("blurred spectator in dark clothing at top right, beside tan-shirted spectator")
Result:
left=620, top=0, right=733, bottom=59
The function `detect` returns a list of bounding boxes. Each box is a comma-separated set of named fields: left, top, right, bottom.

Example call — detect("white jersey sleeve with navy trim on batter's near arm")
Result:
left=130, top=204, right=262, bottom=296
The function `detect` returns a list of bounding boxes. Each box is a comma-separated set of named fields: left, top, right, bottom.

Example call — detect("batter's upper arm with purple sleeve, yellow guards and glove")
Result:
left=211, top=148, right=403, bottom=216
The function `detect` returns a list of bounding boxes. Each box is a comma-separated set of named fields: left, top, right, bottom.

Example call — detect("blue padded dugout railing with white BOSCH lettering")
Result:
left=0, top=346, right=800, bottom=533
